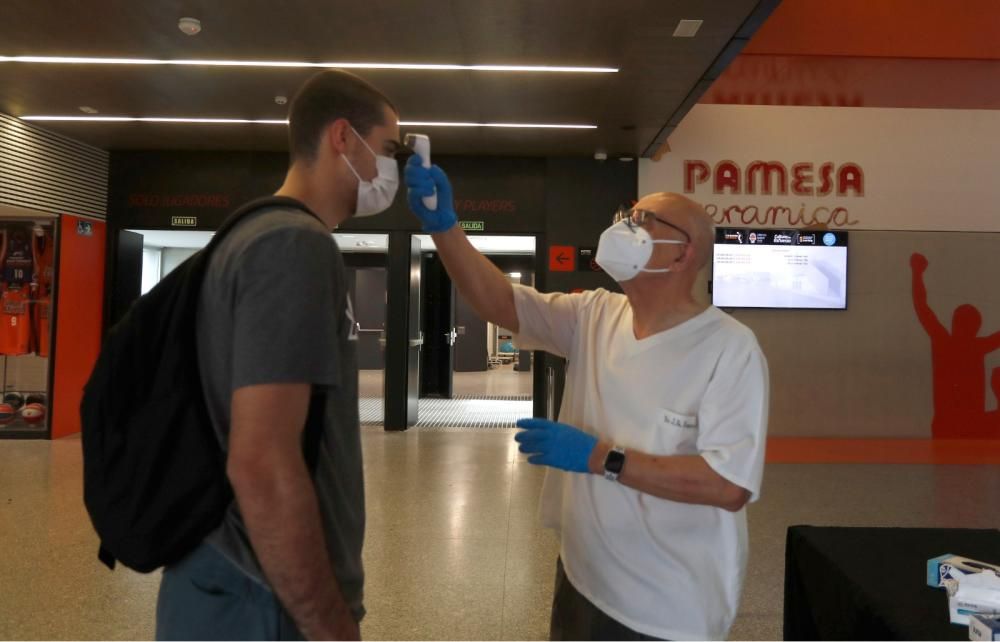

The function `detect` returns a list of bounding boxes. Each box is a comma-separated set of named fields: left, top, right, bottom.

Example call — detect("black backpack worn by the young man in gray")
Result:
left=80, top=197, right=323, bottom=573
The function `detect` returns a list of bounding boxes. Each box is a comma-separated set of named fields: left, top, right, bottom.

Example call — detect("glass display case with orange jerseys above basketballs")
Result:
left=0, top=216, right=58, bottom=437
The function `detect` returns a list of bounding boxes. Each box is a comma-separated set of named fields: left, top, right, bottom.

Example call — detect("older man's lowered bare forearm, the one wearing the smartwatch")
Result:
left=588, top=441, right=750, bottom=511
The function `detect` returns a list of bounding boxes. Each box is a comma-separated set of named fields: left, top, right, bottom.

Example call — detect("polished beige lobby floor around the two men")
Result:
left=0, top=428, right=1000, bottom=640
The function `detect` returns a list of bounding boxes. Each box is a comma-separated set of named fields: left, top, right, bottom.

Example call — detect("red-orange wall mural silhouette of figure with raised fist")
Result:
left=910, top=253, right=1000, bottom=439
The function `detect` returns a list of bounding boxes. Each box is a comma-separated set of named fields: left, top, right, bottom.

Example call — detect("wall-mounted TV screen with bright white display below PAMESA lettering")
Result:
left=712, top=227, right=847, bottom=310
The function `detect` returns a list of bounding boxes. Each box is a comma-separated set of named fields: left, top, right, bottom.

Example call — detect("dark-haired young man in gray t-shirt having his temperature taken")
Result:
left=157, top=71, right=400, bottom=640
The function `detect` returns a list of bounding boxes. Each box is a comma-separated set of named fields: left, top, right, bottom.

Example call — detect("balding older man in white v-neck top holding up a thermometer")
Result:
left=406, top=159, right=768, bottom=640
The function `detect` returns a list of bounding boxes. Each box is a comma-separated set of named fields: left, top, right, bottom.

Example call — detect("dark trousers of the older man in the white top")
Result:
left=549, top=559, right=659, bottom=641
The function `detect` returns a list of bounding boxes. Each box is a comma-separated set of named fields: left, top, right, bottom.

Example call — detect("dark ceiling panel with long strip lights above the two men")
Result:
left=0, top=0, right=776, bottom=155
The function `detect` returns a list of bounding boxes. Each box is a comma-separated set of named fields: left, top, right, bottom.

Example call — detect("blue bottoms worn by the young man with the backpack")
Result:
left=156, top=544, right=304, bottom=640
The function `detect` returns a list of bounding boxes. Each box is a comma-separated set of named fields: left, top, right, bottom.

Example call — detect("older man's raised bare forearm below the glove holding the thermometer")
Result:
left=433, top=225, right=519, bottom=332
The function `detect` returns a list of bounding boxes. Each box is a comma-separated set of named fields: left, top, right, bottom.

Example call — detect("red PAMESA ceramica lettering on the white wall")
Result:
left=684, top=160, right=865, bottom=227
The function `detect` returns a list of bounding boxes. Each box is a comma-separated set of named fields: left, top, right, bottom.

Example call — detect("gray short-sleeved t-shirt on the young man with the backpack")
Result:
left=197, top=208, right=365, bottom=619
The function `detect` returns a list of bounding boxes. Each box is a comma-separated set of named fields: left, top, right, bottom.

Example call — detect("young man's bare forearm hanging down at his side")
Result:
left=231, top=444, right=353, bottom=639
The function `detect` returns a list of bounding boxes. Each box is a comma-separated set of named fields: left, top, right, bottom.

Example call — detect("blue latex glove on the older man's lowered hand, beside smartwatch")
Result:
left=514, top=417, right=597, bottom=473
